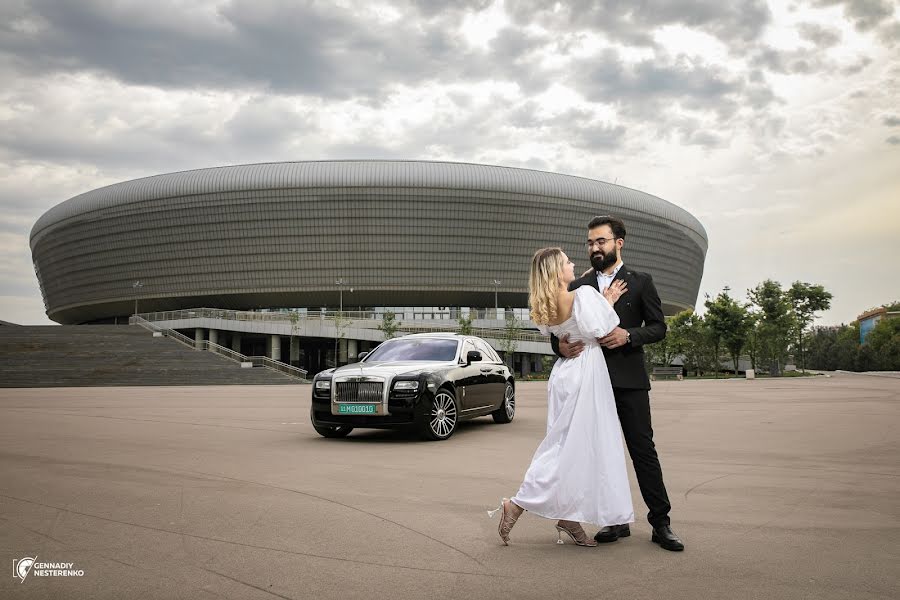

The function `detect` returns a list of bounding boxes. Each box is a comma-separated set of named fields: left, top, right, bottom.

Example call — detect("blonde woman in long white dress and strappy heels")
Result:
left=489, top=248, right=634, bottom=546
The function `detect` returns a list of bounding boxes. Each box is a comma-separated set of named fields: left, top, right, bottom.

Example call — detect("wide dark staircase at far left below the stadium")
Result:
left=0, top=325, right=301, bottom=388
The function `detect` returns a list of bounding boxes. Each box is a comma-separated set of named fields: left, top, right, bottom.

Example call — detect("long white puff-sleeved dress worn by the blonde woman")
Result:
left=512, top=285, right=634, bottom=527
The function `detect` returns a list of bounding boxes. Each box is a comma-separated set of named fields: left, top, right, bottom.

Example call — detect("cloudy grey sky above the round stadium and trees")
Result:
left=0, top=0, right=900, bottom=324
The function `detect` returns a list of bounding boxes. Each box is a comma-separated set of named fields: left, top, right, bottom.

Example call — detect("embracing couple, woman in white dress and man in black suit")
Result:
left=491, top=216, right=684, bottom=551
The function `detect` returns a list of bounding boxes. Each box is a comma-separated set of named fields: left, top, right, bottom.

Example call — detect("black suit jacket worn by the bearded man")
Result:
left=550, top=264, right=666, bottom=390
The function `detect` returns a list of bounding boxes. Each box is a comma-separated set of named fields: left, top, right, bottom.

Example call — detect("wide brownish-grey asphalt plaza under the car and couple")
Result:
left=0, top=374, right=900, bottom=600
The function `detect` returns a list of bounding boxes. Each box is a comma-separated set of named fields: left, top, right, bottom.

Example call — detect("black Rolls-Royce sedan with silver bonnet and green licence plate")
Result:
left=310, top=333, right=516, bottom=440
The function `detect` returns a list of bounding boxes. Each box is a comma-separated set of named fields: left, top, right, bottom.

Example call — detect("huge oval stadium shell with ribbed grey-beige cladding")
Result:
left=31, top=161, right=707, bottom=323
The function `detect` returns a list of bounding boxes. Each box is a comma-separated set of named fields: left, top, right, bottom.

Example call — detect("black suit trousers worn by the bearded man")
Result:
left=613, top=388, right=672, bottom=527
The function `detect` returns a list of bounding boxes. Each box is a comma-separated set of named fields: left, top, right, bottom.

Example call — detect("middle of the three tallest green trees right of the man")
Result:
left=747, top=279, right=795, bottom=376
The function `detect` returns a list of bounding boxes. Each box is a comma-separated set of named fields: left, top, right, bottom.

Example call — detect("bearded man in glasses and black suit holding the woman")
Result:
left=551, top=216, right=684, bottom=551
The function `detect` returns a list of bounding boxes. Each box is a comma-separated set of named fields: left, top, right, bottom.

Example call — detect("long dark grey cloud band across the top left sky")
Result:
left=0, top=0, right=500, bottom=97
